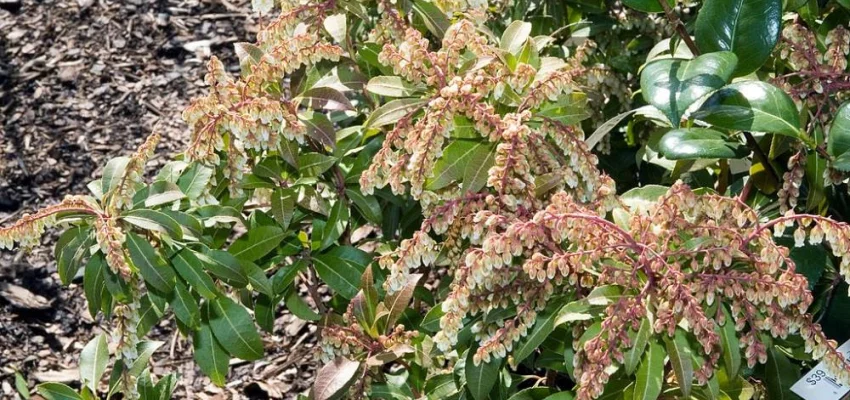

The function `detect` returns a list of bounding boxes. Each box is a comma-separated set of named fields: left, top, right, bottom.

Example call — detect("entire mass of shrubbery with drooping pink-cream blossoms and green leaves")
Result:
left=0, top=0, right=850, bottom=399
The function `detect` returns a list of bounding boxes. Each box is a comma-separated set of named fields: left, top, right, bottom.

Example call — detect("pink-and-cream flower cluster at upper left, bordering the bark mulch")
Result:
left=183, top=2, right=343, bottom=196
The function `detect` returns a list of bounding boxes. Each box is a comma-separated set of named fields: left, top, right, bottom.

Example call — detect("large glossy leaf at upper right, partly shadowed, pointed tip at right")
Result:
left=694, top=81, right=804, bottom=138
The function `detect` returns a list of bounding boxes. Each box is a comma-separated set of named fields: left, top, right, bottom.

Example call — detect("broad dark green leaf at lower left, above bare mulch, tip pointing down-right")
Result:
left=210, top=297, right=263, bottom=361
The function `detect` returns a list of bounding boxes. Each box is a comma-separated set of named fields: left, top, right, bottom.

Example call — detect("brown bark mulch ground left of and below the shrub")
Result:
left=0, top=0, right=315, bottom=399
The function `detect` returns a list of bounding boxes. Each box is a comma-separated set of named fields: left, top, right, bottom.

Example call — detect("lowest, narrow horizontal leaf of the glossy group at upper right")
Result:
left=658, top=128, right=750, bottom=160
